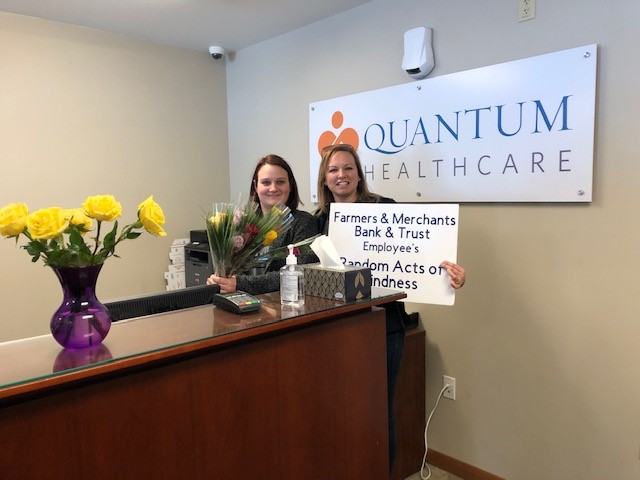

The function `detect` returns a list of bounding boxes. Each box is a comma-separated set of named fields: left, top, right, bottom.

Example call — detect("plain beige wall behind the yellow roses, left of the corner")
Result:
left=0, top=13, right=229, bottom=342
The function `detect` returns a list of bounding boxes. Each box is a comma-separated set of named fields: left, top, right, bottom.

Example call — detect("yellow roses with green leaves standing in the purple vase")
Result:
left=0, top=195, right=166, bottom=267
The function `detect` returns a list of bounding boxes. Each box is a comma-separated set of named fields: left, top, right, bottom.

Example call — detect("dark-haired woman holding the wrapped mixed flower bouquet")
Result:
left=207, top=155, right=318, bottom=295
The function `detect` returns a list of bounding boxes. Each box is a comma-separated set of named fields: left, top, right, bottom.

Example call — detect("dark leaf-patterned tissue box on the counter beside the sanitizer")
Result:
left=300, top=263, right=371, bottom=302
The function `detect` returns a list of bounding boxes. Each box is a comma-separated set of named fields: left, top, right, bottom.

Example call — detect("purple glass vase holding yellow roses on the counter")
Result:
left=50, top=265, right=111, bottom=349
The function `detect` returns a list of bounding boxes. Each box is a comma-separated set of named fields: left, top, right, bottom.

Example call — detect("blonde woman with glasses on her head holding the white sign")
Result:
left=315, top=143, right=465, bottom=471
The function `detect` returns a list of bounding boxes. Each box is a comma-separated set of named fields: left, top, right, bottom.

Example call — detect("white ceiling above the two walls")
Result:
left=0, top=0, right=371, bottom=51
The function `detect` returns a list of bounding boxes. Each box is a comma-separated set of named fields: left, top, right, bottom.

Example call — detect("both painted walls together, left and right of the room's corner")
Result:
left=0, top=0, right=640, bottom=480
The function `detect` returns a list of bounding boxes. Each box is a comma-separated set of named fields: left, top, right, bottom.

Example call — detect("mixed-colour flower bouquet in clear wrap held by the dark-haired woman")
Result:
left=206, top=202, right=293, bottom=277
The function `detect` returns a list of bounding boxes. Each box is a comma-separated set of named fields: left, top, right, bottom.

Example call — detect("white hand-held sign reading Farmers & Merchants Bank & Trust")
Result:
left=329, top=203, right=459, bottom=305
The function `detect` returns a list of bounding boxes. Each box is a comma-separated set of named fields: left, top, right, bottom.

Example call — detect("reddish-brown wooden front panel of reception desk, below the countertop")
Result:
left=0, top=309, right=388, bottom=480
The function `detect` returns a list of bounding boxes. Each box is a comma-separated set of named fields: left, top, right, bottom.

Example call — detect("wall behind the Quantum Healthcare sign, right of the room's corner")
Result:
left=227, top=0, right=640, bottom=480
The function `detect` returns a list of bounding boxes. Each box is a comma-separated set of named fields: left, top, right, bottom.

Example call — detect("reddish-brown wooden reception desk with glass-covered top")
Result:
left=0, top=288, right=405, bottom=480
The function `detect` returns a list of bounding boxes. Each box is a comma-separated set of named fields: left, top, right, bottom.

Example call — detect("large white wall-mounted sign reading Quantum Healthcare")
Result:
left=309, top=44, right=597, bottom=202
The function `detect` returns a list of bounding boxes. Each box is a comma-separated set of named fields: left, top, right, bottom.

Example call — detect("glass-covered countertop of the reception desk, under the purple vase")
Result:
left=0, top=287, right=406, bottom=399
